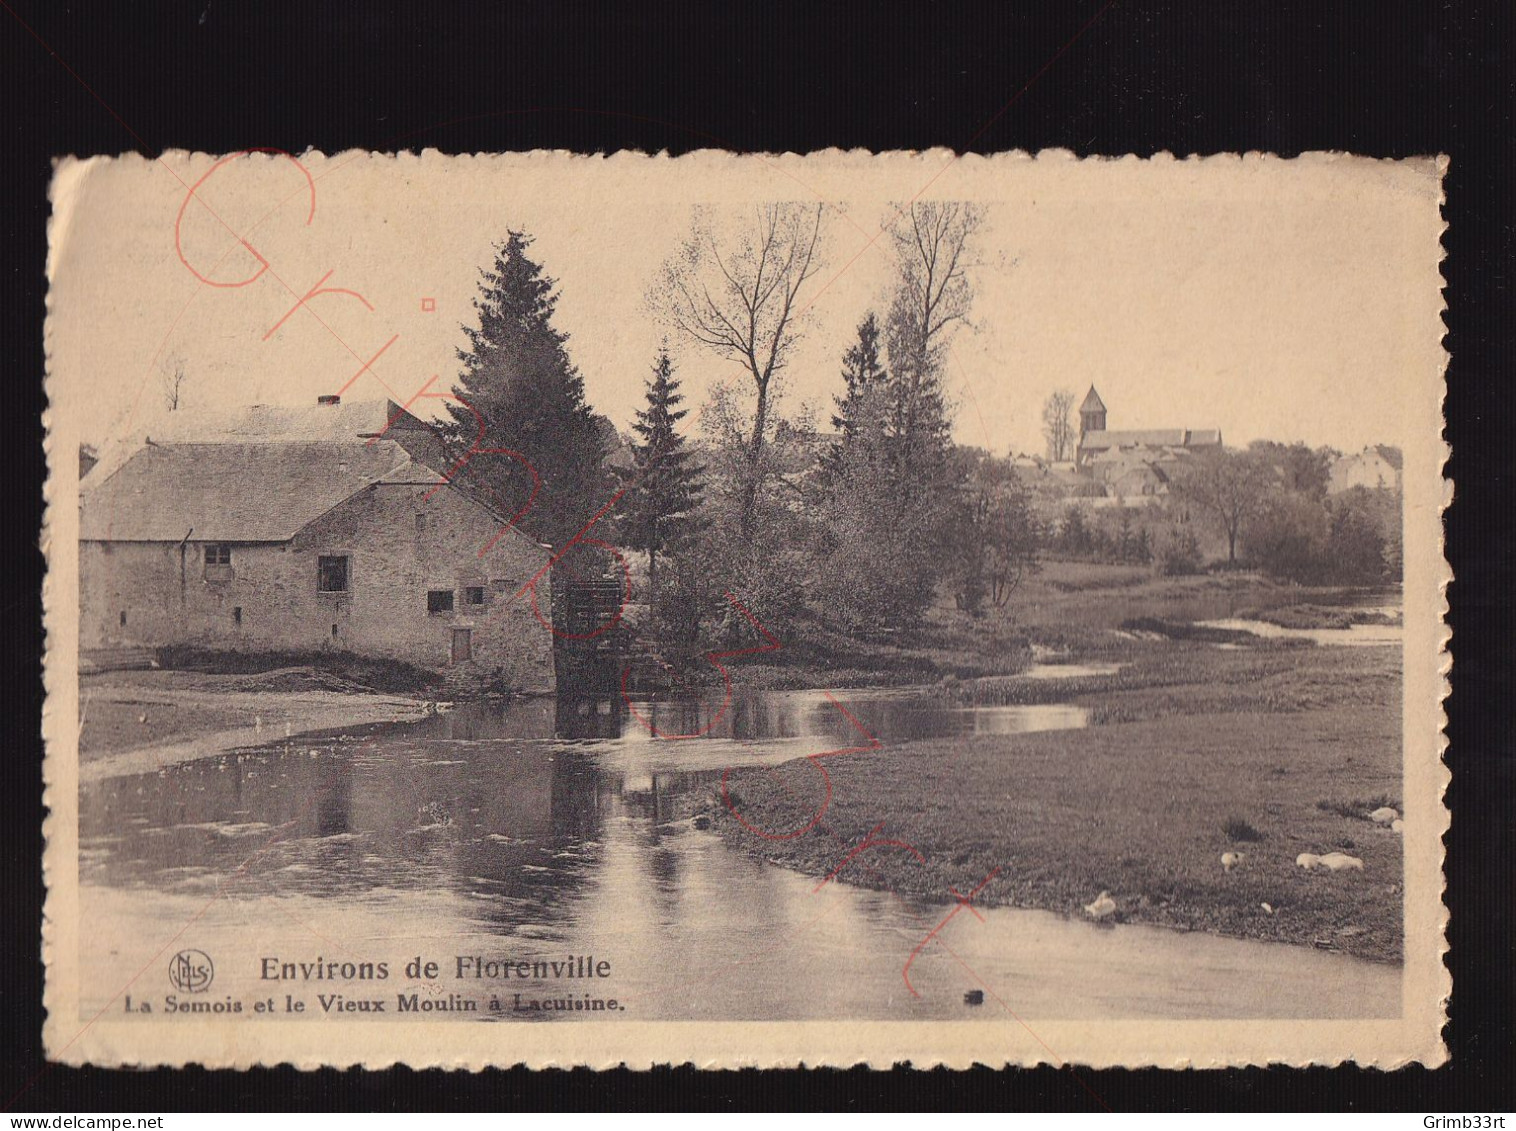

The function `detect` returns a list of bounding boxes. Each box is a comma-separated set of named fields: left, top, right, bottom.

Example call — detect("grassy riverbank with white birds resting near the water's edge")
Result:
left=703, top=641, right=1402, bottom=963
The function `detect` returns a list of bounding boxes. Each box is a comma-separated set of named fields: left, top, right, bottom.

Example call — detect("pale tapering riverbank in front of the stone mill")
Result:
left=79, top=669, right=429, bottom=781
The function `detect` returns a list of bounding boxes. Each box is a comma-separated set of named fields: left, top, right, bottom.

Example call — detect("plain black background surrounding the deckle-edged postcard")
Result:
left=0, top=0, right=1516, bottom=1113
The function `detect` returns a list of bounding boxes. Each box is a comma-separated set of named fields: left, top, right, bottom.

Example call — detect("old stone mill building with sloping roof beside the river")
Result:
left=79, top=397, right=555, bottom=691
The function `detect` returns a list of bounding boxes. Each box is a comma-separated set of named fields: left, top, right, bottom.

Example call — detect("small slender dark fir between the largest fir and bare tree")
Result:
left=622, top=347, right=703, bottom=599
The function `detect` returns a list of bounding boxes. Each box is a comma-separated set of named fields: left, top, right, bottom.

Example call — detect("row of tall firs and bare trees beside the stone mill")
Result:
left=447, top=202, right=1037, bottom=640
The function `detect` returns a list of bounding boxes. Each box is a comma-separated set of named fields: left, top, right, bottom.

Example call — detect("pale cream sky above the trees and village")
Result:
left=47, top=153, right=1440, bottom=453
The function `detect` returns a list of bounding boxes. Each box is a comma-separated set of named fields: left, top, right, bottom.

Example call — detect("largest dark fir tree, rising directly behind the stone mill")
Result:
left=449, top=230, right=605, bottom=546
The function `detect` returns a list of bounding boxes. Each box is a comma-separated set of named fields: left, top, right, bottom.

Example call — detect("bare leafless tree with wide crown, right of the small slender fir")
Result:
left=649, top=203, right=822, bottom=537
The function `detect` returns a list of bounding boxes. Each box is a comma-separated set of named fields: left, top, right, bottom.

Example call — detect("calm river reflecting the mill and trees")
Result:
left=80, top=691, right=1399, bottom=1020
